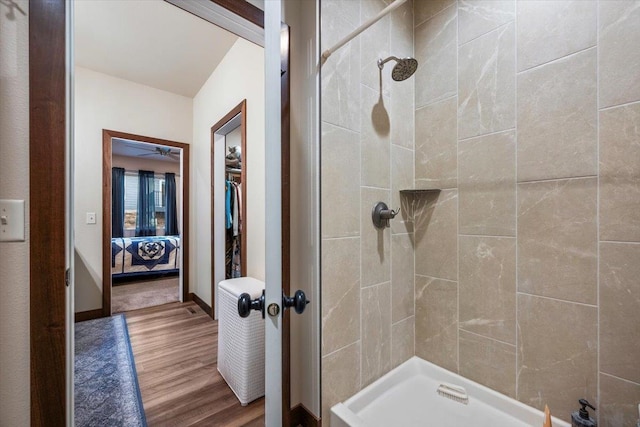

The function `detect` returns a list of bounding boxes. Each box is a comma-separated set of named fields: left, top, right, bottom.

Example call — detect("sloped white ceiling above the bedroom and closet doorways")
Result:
left=74, top=0, right=238, bottom=98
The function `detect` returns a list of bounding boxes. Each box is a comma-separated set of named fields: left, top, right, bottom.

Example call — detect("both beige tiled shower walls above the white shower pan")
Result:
left=322, top=0, right=640, bottom=426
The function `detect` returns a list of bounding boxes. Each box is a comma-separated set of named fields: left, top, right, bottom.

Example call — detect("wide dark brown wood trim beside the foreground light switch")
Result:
left=28, top=0, right=67, bottom=426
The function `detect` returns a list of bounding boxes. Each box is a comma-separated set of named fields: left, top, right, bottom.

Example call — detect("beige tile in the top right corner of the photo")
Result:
left=598, top=0, right=640, bottom=108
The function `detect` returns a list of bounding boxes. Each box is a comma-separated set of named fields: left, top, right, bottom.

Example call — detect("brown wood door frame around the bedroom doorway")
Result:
left=102, top=129, right=190, bottom=316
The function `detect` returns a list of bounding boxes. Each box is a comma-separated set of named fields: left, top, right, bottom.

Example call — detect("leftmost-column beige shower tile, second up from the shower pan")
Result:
left=322, top=237, right=360, bottom=355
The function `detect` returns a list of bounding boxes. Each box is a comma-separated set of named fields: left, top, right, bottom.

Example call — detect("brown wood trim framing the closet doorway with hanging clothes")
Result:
left=211, top=99, right=248, bottom=318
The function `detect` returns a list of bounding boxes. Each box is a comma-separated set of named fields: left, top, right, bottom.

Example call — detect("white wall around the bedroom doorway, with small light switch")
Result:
left=74, top=67, right=193, bottom=312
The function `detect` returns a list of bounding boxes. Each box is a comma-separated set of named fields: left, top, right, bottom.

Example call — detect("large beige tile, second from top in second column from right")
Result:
left=517, top=48, right=597, bottom=181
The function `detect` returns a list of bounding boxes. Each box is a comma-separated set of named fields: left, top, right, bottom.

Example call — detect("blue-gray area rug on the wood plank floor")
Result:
left=74, top=314, right=147, bottom=427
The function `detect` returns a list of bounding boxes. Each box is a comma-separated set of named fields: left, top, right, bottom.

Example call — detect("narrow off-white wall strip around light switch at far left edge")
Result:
left=0, top=0, right=30, bottom=427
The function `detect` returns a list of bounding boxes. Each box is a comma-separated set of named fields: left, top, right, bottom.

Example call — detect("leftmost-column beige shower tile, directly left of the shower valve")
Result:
left=320, top=123, right=360, bottom=238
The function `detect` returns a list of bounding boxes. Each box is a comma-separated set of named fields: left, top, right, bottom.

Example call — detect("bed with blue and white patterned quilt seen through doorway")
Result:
left=111, top=236, right=180, bottom=278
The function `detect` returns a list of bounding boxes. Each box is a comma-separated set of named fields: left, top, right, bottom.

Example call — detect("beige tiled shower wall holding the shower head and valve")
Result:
left=321, top=0, right=416, bottom=425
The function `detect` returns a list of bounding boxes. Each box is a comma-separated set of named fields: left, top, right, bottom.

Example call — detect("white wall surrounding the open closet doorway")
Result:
left=190, top=39, right=265, bottom=310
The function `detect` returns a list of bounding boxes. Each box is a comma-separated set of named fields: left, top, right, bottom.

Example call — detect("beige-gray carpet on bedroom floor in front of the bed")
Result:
left=111, top=277, right=180, bottom=313
